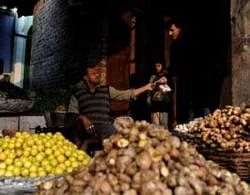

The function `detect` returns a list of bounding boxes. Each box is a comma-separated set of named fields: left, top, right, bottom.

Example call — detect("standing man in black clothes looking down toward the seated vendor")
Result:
left=167, top=19, right=201, bottom=124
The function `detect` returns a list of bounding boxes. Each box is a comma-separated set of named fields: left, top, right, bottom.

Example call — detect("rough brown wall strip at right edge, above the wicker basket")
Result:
left=231, top=0, right=250, bottom=105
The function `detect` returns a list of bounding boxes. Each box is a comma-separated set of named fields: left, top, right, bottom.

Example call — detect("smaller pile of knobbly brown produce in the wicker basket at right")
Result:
left=176, top=106, right=250, bottom=152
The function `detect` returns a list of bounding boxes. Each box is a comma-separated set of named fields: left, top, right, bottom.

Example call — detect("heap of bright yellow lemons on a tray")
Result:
left=0, top=132, right=91, bottom=177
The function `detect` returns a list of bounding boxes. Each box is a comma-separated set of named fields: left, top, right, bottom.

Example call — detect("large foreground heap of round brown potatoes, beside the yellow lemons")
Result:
left=37, top=118, right=250, bottom=195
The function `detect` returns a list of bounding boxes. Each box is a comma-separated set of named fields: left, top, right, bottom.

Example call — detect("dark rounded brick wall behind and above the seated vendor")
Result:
left=30, top=0, right=107, bottom=88
